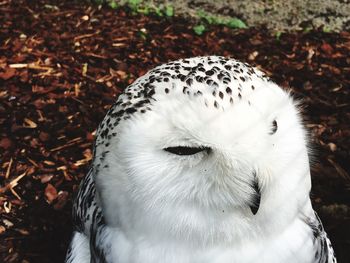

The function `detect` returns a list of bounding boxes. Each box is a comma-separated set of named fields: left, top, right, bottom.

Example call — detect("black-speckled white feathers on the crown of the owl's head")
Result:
left=91, top=57, right=268, bottom=169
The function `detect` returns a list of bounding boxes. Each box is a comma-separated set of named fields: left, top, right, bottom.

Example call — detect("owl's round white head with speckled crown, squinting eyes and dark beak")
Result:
left=93, top=57, right=309, bottom=231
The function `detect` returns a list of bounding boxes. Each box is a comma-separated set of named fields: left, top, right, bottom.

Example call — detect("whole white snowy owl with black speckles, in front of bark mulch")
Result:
left=66, top=56, right=336, bottom=263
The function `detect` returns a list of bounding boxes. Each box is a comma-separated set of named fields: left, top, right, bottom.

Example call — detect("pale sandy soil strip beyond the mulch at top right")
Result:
left=142, top=0, right=350, bottom=32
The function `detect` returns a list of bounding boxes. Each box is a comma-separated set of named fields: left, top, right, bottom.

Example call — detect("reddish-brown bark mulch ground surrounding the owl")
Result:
left=0, top=0, right=350, bottom=262
